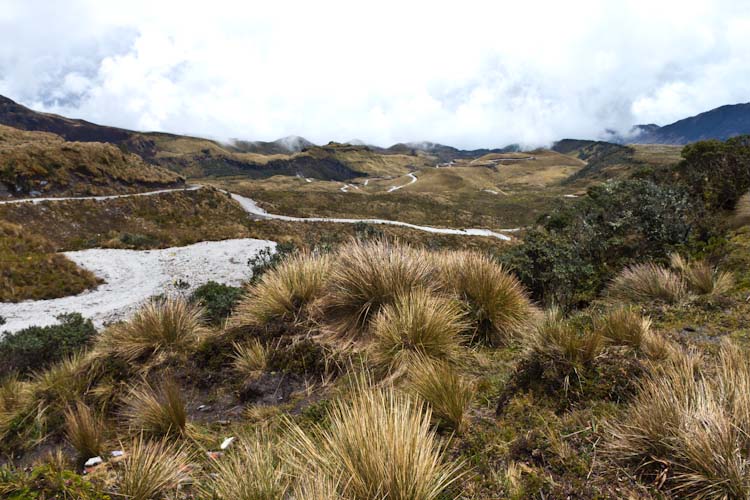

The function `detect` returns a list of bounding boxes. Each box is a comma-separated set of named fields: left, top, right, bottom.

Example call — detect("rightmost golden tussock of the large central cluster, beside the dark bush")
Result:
left=435, top=251, right=532, bottom=345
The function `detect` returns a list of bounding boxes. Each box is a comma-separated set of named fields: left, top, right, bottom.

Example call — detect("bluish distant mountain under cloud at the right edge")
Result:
left=628, top=103, right=750, bottom=144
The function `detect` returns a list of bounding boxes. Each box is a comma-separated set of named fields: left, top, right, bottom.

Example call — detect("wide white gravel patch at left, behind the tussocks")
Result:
left=0, top=238, right=276, bottom=332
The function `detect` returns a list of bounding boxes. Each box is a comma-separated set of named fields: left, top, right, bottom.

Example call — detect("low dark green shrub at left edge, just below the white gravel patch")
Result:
left=0, top=313, right=96, bottom=378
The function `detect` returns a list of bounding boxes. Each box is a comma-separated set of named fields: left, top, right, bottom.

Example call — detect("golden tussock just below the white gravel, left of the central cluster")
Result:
left=97, top=297, right=206, bottom=361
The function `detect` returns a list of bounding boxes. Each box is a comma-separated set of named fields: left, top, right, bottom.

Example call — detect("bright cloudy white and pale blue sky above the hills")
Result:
left=0, top=0, right=750, bottom=148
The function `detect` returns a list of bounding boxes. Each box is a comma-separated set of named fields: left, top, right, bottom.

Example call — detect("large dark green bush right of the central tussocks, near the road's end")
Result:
left=501, top=180, right=701, bottom=307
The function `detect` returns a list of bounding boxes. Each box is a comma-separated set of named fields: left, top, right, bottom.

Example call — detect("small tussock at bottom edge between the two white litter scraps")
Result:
left=117, top=436, right=189, bottom=500
